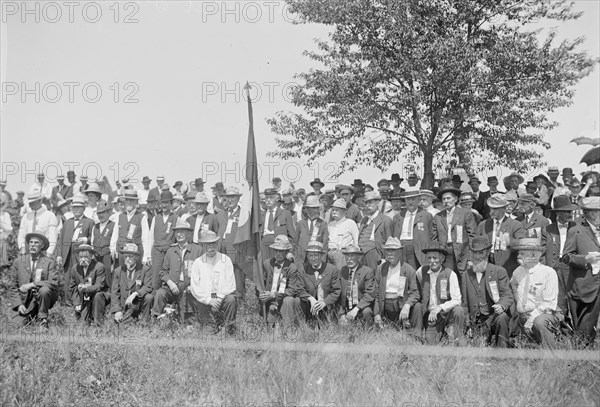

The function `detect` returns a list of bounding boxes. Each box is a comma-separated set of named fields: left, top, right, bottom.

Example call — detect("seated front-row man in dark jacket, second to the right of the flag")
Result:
left=299, top=241, right=345, bottom=323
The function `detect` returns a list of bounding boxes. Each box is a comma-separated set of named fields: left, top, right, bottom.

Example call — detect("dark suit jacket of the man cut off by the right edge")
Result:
left=563, top=221, right=600, bottom=303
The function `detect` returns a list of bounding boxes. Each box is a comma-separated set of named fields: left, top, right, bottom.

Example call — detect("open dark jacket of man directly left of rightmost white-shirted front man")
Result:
left=461, top=263, right=514, bottom=322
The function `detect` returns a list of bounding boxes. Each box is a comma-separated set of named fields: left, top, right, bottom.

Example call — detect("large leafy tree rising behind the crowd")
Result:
left=268, top=0, right=598, bottom=187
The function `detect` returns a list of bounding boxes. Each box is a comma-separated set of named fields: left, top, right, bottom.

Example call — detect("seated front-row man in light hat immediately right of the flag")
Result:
left=257, top=235, right=302, bottom=327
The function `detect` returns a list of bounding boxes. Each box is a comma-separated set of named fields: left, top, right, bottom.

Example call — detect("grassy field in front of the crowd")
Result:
left=0, top=280, right=600, bottom=407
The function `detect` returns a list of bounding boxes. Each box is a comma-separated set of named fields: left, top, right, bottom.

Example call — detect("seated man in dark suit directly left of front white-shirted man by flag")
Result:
left=152, top=218, right=202, bottom=322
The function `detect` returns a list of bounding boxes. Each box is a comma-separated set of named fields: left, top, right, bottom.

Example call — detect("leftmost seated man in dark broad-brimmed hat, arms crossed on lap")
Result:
left=11, top=233, right=58, bottom=328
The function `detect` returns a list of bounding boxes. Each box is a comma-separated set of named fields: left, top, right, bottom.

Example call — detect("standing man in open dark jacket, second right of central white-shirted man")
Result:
left=393, top=187, right=434, bottom=270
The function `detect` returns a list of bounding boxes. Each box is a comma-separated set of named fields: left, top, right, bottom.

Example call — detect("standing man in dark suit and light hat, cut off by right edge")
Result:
left=563, top=196, right=600, bottom=343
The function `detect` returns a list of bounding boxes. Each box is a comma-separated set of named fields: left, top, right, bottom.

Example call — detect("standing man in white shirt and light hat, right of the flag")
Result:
left=327, top=198, right=358, bottom=272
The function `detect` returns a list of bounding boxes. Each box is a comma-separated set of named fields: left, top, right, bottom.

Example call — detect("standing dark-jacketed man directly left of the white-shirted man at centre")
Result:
left=294, top=195, right=329, bottom=268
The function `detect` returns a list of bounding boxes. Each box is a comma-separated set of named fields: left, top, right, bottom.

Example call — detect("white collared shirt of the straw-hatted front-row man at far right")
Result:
left=510, top=263, right=558, bottom=318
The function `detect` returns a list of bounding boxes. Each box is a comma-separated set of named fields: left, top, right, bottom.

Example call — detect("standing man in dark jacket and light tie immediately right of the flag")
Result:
left=260, top=188, right=296, bottom=259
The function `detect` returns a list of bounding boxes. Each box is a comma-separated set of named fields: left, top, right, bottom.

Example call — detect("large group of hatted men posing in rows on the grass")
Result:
left=2, top=167, right=600, bottom=347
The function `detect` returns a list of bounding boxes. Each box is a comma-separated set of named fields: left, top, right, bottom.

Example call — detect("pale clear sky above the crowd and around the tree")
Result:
left=0, top=0, right=600, bottom=191
